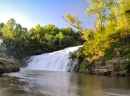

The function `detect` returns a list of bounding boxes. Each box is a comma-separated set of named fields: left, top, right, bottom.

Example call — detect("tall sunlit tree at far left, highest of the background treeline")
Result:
left=1, top=18, right=26, bottom=58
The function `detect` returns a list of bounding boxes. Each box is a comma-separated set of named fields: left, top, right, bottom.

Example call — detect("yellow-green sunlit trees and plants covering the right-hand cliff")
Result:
left=64, top=0, right=130, bottom=73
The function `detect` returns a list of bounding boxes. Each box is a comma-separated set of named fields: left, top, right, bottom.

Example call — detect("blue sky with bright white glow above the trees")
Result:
left=0, top=0, right=92, bottom=29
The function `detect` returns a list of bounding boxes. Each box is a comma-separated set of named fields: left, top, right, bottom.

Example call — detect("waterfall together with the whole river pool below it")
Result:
left=0, top=46, right=130, bottom=96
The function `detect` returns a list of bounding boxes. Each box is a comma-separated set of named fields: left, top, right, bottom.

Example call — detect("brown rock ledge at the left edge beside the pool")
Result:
left=0, top=58, right=20, bottom=74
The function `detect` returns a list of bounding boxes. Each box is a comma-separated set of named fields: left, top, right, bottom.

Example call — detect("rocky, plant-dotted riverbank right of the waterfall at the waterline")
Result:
left=74, top=55, right=130, bottom=77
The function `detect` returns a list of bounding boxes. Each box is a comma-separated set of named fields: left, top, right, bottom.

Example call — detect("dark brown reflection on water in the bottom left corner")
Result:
left=0, top=76, right=29, bottom=96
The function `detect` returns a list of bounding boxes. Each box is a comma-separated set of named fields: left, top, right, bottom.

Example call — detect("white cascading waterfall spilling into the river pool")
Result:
left=26, top=46, right=82, bottom=71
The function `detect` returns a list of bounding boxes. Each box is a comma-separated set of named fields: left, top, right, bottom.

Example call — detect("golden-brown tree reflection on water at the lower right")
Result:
left=78, top=74, right=130, bottom=96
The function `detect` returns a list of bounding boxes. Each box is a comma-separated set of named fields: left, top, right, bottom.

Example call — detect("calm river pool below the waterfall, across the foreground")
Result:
left=0, top=69, right=130, bottom=96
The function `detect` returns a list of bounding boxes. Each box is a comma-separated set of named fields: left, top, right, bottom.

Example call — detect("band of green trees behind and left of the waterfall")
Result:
left=0, top=18, right=82, bottom=59
